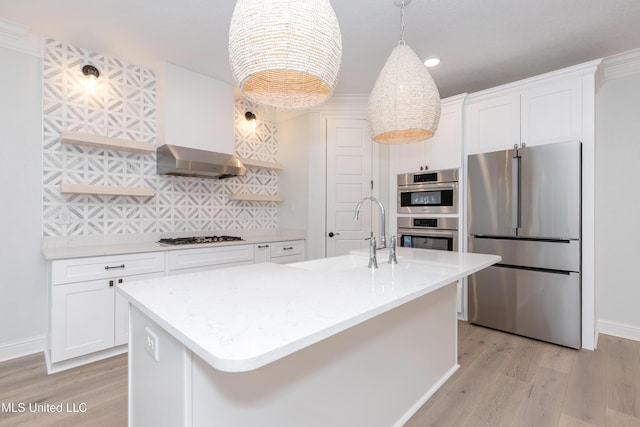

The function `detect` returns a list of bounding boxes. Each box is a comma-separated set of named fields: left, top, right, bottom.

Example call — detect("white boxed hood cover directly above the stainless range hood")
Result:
left=162, top=64, right=234, bottom=154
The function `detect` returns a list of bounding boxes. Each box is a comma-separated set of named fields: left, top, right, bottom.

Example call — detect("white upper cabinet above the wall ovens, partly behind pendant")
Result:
left=392, top=95, right=466, bottom=174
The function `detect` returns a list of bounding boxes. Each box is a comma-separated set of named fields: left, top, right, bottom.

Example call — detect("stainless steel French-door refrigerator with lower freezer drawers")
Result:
left=467, top=142, right=582, bottom=348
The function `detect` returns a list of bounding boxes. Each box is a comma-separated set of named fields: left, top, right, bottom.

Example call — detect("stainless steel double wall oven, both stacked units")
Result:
left=397, top=169, right=458, bottom=251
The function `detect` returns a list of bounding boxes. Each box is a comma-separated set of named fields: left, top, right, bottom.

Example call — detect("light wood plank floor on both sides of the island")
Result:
left=0, top=322, right=640, bottom=427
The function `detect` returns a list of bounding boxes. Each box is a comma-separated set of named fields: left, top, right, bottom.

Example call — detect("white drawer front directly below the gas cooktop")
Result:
left=169, top=245, right=253, bottom=271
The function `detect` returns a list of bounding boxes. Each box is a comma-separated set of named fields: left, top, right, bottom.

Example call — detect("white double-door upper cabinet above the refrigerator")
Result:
left=467, top=71, right=582, bottom=154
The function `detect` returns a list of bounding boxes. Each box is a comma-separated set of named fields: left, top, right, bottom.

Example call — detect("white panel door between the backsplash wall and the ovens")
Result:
left=326, top=119, right=378, bottom=256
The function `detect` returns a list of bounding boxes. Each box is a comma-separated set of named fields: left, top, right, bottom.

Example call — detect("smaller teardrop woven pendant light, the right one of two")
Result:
left=367, top=0, right=440, bottom=144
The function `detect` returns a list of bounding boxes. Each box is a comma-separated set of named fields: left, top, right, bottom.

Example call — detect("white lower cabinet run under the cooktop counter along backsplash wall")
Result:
left=48, top=240, right=304, bottom=372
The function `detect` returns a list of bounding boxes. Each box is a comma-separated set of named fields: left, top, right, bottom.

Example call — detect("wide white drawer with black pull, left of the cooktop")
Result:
left=51, top=252, right=164, bottom=285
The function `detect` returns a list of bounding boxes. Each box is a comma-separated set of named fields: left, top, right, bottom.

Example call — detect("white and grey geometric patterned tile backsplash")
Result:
left=42, top=39, right=278, bottom=236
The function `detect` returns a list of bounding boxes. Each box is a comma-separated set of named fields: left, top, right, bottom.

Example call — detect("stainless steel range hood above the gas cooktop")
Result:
left=157, top=144, right=246, bottom=179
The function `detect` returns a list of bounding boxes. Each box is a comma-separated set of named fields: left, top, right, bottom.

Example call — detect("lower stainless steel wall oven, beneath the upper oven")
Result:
left=398, top=217, right=458, bottom=251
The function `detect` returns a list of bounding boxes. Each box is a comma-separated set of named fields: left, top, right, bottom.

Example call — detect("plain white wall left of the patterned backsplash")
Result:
left=0, top=43, right=47, bottom=360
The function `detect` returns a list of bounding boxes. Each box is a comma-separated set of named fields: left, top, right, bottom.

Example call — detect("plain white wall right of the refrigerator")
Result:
left=596, top=72, right=640, bottom=340
